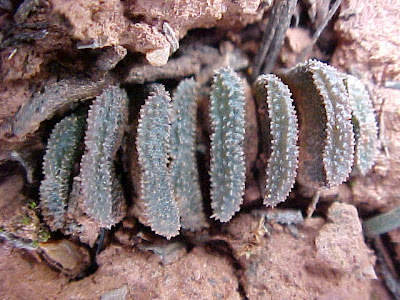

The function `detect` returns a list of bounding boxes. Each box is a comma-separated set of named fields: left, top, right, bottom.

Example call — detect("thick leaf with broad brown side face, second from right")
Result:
left=281, top=60, right=354, bottom=189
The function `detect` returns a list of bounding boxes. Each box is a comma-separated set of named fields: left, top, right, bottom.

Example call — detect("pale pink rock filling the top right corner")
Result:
left=332, top=0, right=400, bottom=83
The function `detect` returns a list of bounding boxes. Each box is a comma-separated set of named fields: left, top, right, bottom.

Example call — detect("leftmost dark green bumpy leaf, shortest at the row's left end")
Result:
left=40, top=113, right=86, bottom=231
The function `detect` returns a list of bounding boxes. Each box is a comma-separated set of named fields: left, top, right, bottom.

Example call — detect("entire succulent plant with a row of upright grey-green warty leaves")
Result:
left=13, top=60, right=377, bottom=239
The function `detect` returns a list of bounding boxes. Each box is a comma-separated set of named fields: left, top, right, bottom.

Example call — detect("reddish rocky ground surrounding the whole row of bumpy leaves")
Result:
left=0, top=0, right=400, bottom=299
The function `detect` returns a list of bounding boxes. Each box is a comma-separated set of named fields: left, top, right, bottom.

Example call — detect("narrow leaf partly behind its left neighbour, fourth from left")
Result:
left=170, top=79, right=207, bottom=230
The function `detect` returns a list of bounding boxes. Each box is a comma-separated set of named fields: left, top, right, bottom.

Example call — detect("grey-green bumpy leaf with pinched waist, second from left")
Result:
left=81, top=86, right=128, bottom=228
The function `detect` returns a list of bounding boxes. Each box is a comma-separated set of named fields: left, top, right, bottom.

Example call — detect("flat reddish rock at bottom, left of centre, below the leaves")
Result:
left=58, top=246, right=240, bottom=300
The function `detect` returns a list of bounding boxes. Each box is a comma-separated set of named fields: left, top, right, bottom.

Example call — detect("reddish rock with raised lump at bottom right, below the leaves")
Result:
left=229, top=203, right=376, bottom=299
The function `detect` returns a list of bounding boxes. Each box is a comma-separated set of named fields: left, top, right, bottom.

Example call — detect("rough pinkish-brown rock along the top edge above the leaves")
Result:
left=50, top=0, right=268, bottom=65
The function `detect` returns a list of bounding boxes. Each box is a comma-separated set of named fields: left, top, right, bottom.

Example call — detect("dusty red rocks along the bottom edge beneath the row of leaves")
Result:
left=0, top=203, right=375, bottom=299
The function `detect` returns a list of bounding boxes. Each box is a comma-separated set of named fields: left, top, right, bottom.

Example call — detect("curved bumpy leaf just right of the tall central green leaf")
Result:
left=255, top=75, right=299, bottom=206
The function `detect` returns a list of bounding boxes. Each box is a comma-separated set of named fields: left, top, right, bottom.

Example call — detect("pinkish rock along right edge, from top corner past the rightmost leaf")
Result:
left=332, top=0, right=400, bottom=212
